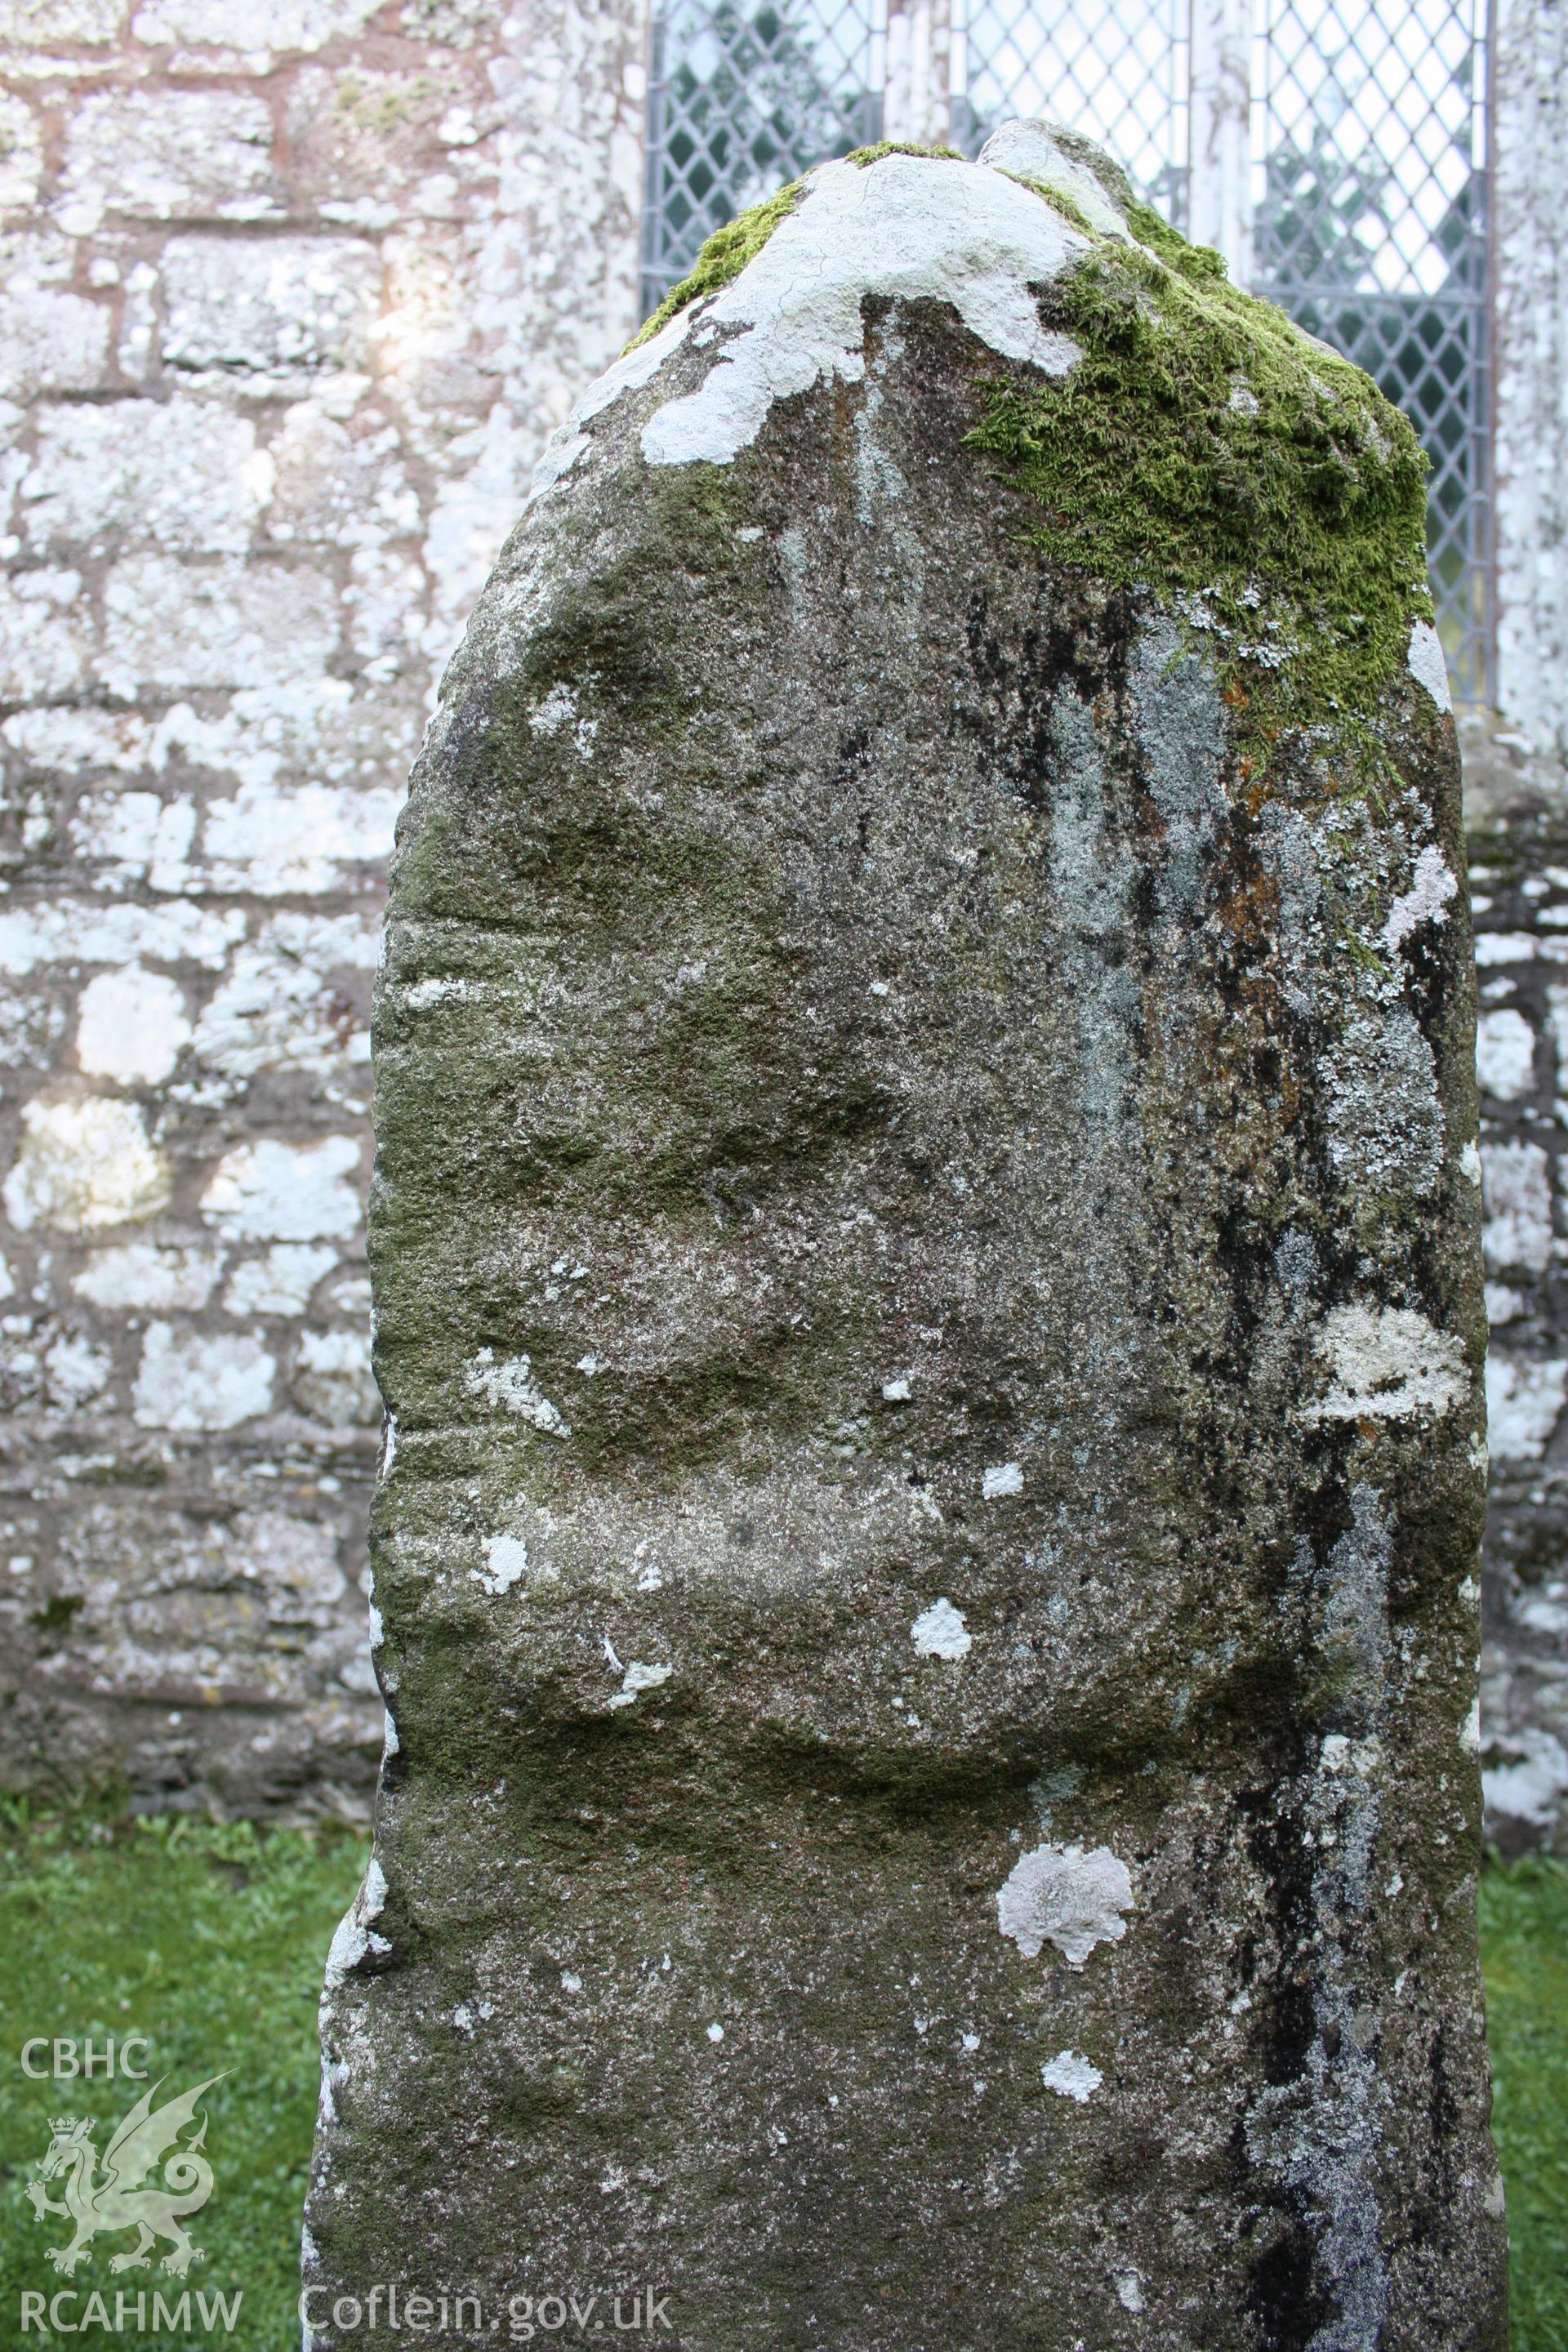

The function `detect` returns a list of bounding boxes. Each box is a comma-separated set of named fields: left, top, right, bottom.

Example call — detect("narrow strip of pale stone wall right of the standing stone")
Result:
left=1467, top=0, right=1568, bottom=1853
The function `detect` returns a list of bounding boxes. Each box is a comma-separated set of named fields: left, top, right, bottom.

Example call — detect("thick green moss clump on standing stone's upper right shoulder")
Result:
left=969, top=205, right=1432, bottom=755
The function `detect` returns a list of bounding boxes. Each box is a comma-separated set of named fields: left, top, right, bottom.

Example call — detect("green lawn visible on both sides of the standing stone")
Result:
left=0, top=1809, right=1568, bottom=2352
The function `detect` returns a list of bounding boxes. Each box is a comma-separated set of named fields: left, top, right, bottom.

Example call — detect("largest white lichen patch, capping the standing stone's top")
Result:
left=637, top=155, right=1089, bottom=466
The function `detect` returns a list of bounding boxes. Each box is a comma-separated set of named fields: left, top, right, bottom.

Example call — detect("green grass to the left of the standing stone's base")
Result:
left=0, top=1809, right=367, bottom=2352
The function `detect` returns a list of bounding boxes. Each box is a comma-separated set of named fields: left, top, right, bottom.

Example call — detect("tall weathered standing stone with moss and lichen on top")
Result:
left=305, top=125, right=1504, bottom=2352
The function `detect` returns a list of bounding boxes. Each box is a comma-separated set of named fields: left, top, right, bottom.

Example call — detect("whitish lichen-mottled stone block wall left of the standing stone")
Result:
left=0, top=0, right=644, bottom=1806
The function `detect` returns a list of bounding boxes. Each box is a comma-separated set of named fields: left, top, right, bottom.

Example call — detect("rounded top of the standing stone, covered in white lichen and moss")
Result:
left=512, top=120, right=1443, bottom=760
